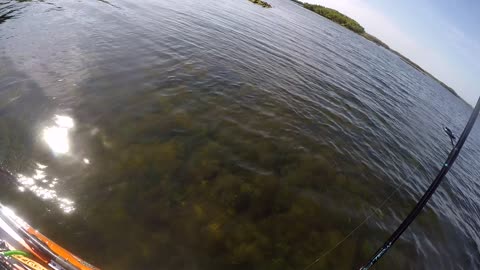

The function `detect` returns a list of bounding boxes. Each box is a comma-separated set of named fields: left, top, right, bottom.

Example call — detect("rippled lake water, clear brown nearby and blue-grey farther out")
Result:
left=0, top=0, right=480, bottom=269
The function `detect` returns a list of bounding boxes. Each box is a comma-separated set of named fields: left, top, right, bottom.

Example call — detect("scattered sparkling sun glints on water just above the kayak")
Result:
left=17, top=163, right=75, bottom=214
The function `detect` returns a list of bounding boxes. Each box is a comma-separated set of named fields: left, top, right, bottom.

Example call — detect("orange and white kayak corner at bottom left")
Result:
left=0, top=204, right=99, bottom=270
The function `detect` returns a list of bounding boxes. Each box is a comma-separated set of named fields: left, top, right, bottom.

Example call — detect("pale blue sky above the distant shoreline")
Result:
left=306, top=0, right=480, bottom=105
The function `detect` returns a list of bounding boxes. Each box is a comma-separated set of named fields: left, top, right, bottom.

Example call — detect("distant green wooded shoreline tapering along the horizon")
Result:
left=291, top=0, right=471, bottom=106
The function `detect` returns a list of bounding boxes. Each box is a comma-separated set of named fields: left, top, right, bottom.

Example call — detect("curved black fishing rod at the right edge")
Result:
left=360, top=98, right=480, bottom=270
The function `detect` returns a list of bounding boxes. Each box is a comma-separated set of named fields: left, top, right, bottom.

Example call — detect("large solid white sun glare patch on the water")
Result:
left=42, top=115, right=75, bottom=154
